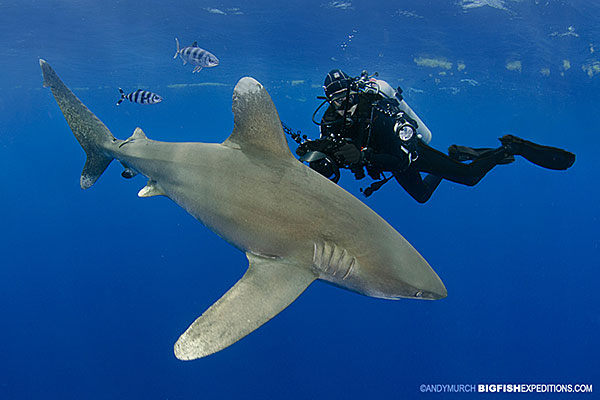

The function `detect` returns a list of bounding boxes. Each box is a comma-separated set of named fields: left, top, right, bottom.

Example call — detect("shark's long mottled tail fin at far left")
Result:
left=40, top=59, right=117, bottom=189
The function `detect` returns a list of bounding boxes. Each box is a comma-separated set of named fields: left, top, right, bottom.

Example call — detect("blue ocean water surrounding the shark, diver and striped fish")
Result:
left=0, top=0, right=600, bottom=399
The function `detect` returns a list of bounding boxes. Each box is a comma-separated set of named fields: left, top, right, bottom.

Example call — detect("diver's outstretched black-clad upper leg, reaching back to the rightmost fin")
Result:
left=413, top=142, right=510, bottom=186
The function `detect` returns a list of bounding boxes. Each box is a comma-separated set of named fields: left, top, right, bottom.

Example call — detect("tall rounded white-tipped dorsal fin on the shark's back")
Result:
left=223, top=77, right=293, bottom=158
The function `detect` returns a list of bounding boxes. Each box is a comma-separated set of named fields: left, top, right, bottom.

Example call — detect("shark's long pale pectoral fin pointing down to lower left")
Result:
left=175, top=253, right=317, bottom=360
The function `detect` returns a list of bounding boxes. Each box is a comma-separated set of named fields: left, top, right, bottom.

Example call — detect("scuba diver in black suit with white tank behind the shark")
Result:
left=296, top=69, right=575, bottom=203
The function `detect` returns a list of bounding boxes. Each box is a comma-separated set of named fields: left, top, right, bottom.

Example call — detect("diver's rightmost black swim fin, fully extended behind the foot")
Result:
left=499, top=135, right=575, bottom=170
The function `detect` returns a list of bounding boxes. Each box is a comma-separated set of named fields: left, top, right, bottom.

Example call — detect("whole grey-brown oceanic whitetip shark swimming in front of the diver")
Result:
left=40, top=60, right=447, bottom=360
